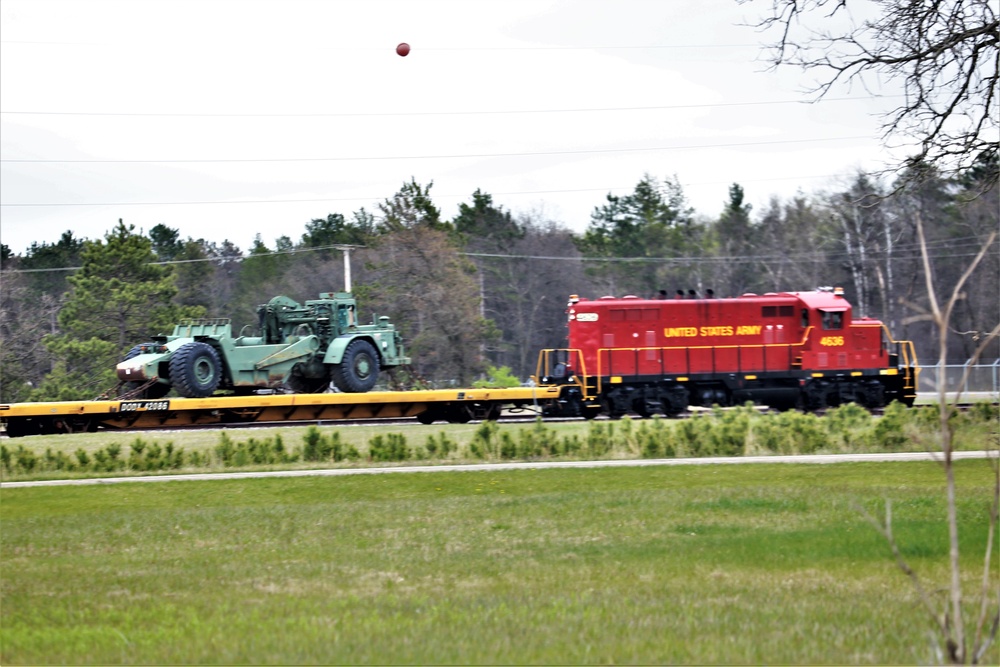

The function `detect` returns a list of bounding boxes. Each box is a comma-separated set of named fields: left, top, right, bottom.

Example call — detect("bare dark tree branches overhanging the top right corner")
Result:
left=737, top=0, right=1000, bottom=188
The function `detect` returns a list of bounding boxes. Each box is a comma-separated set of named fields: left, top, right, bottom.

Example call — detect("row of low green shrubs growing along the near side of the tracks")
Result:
left=0, top=403, right=1000, bottom=474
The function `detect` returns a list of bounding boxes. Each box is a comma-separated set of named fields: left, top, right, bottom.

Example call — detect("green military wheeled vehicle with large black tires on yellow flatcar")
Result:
left=117, top=292, right=410, bottom=399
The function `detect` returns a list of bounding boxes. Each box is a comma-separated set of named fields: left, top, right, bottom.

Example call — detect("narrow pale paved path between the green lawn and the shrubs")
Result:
left=0, top=451, right=1000, bottom=489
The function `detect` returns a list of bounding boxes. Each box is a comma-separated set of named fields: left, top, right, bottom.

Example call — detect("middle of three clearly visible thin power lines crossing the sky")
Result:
left=0, top=135, right=870, bottom=164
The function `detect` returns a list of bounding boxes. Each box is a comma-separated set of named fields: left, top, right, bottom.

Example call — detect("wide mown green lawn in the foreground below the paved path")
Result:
left=0, top=461, right=1000, bottom=665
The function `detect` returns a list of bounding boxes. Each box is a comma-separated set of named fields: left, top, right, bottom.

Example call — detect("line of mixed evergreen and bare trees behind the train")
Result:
left=0, top=162, right=1000, bottom=402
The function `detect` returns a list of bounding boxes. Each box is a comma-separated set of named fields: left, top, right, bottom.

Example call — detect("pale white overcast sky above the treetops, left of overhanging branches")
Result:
left=0, top=0, right=899, bottom=253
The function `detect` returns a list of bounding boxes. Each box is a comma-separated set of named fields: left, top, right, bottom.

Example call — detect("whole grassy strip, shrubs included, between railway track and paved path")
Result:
left=0, top=403, right=998, bottom=480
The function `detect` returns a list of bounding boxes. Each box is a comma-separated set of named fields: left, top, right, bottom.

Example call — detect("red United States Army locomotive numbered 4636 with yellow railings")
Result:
left=538, top=288, right=919, bottom=417
